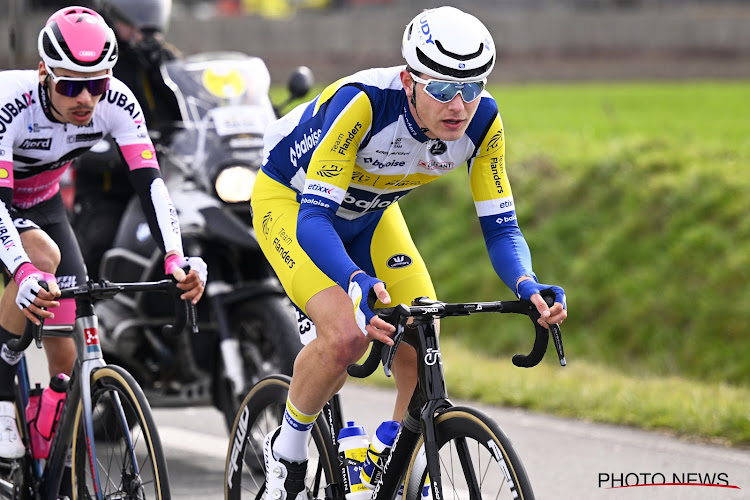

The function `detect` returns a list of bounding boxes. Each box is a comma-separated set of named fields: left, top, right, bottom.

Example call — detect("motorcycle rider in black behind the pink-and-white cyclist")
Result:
left=72, top=0, right=180, bottom=281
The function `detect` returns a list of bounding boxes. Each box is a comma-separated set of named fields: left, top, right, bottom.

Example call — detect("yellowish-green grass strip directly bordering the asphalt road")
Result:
left=356, top=338, right=750, bottom=447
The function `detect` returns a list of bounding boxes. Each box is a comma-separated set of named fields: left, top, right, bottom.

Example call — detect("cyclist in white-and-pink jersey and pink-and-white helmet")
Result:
left=0, top=7, right=206, bottom=458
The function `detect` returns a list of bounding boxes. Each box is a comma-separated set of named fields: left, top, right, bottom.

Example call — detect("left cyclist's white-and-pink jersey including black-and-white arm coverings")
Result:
left=0, top=70, right=183, bottom=278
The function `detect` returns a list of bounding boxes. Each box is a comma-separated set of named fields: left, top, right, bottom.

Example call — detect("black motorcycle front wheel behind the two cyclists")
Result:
left=214, top=295, right=302, bottom=430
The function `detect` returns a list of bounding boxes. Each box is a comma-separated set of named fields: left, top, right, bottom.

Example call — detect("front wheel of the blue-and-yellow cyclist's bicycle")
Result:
left=404, top=407, right=534, bottom=500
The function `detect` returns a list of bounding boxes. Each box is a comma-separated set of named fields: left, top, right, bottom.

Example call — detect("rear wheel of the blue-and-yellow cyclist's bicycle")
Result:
left=224, top=375, right=338, bottom=500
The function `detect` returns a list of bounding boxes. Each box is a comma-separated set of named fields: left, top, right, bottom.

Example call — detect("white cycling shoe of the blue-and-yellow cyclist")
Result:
left=263, top=427, right=307, bottom=500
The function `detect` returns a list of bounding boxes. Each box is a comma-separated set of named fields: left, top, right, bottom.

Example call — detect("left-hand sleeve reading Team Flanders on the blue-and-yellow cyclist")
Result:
left=297, top=86, right=372, bottom=290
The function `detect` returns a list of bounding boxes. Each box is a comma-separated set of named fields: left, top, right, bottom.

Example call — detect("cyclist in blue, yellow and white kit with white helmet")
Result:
left=252, top=7, right=567, bottom=499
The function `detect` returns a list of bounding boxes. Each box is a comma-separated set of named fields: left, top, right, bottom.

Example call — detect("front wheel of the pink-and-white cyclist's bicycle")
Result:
left=72, top=365, right=171, bottom=500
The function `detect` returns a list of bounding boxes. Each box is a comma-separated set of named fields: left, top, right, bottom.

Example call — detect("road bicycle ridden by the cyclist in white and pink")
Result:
left=0, top=279, right=197, bottom=500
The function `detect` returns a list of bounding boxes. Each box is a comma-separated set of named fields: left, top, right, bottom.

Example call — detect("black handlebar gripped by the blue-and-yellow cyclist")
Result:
left=347, top=289, right=567, bottom=378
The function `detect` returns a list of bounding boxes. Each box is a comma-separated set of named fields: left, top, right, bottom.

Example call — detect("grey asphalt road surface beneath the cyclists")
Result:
left=23, top=353, right=750, bottom=500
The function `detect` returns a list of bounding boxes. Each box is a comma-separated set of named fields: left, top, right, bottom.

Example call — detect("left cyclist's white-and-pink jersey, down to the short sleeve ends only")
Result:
left=0, top=70, right=158, bottom=208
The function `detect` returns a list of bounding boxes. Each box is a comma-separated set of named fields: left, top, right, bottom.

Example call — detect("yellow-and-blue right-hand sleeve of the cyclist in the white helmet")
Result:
left=469, top=113, right=534, bottom=291
